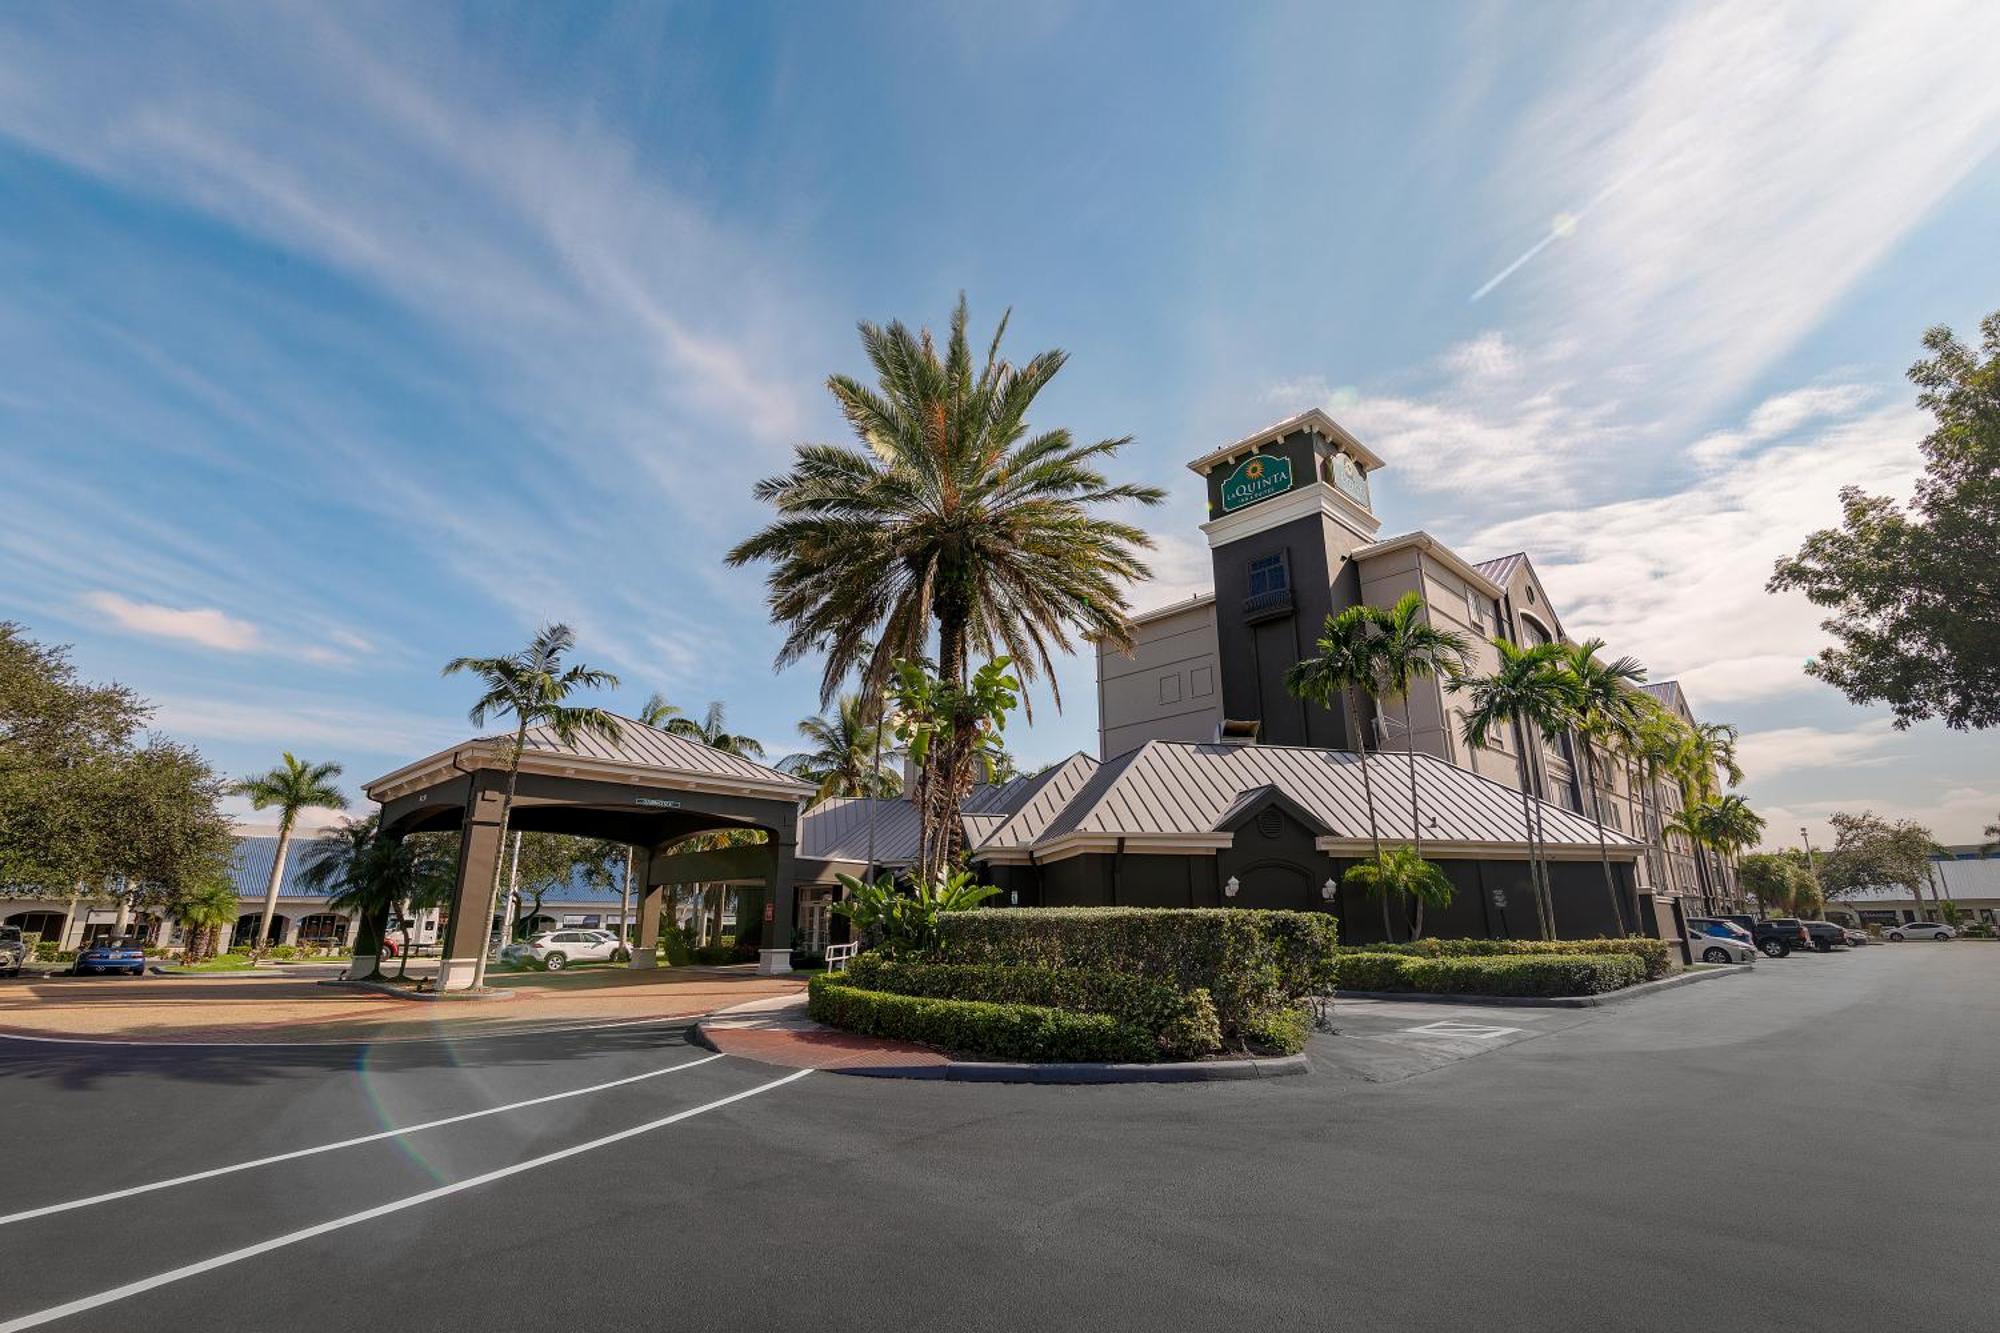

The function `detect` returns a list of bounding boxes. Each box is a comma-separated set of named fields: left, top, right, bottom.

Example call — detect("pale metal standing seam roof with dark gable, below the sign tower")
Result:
left=1038, top=741, right=1638, bottom=847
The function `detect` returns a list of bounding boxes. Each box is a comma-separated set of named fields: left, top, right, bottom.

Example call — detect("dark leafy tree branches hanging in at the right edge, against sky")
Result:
left=1768, top=312, right=2000, bottom=731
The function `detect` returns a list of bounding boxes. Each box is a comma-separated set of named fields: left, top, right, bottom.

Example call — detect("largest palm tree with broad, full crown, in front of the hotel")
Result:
left=728, top=296, right=1166, bottom=868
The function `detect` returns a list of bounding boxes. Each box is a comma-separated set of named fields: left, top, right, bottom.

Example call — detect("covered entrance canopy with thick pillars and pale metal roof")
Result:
left=368, top=719, right=812, bottom=991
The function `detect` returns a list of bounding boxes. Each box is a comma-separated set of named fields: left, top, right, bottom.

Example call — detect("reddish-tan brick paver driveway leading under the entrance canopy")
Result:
left=0, top=967, right=804, bottom=1043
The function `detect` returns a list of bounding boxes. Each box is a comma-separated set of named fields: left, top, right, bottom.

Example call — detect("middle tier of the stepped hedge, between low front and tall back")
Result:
left=840, top=953, right=1222, bottom=1059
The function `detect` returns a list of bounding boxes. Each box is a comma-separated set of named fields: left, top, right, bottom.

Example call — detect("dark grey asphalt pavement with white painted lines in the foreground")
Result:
left=0, top=943, right=2000, bottom=1333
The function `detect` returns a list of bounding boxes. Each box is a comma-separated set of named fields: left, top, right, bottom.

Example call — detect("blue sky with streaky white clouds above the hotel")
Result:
left=0, top=0, right=2000, bottom=841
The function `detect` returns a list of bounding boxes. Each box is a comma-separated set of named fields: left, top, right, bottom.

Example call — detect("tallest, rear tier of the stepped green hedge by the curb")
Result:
left=938, top=907, right=1340, bottom=1045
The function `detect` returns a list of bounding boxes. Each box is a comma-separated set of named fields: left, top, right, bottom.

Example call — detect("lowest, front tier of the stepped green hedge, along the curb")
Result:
left=806, top=975, right=1158, bottom=1063
